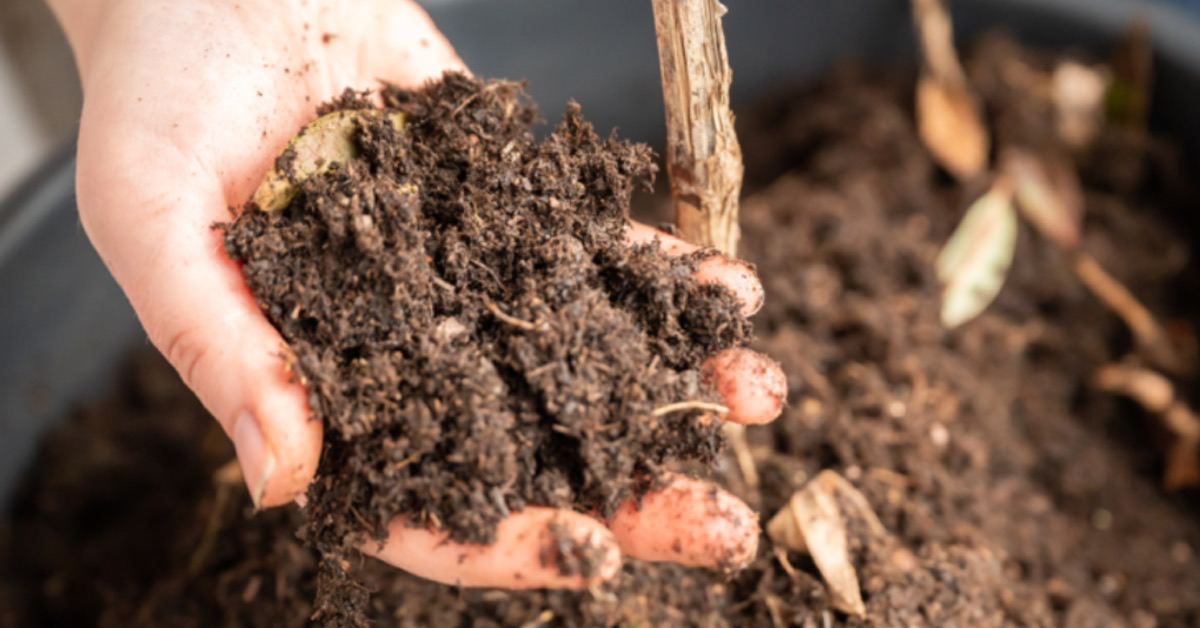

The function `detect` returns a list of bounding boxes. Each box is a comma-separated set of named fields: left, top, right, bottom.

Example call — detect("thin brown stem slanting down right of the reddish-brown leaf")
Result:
left=1072, top=251, right=1188, bottom=375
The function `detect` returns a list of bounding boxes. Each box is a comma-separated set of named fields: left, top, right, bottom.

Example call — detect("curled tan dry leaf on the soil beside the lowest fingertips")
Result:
left=767, top=469, right=887, bottom=616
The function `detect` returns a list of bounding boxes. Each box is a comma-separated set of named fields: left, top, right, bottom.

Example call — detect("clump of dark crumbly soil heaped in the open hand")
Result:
left=224, top=74, right=750, bottom=569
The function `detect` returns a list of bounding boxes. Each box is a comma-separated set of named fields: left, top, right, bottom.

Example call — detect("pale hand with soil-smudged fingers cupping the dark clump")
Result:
left=50, top=0, right=785, bottom=588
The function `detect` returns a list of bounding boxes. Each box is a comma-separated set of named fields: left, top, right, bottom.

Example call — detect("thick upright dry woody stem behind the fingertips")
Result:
left=654, top=0, right=758, bottom=489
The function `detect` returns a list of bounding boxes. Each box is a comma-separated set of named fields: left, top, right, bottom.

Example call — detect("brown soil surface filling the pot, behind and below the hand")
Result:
left=0, top=38, right=1200, bottom=627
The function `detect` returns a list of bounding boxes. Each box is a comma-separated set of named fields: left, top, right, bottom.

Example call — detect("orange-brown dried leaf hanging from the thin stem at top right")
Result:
left=917, top=74, right=991, bottom=180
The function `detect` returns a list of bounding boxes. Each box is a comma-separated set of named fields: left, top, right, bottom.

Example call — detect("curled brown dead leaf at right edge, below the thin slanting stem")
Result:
left=1092, top=363, right=1200, bottom=490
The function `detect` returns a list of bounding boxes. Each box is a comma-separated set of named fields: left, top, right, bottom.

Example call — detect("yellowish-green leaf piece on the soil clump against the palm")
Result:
left=251, top=109, right=404, bottom=211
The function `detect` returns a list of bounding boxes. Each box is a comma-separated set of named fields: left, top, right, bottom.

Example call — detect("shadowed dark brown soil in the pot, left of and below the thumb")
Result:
left=0, top=349, right=317, bottom=628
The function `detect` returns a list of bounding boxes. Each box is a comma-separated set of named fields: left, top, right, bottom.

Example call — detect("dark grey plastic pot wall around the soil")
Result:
left=0, top=0, right=1200, bottom=503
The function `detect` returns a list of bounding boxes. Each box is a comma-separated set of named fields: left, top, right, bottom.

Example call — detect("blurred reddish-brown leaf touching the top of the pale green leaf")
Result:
left=1001, top=149, right=1084, bottom=251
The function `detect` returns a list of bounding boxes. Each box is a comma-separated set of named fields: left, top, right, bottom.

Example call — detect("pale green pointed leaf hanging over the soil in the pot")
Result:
left=937, top=178, right=1016, bottom=329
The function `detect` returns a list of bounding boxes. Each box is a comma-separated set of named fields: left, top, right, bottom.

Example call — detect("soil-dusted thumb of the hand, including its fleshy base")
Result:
left=77, top=135, right=322, bottom=506
